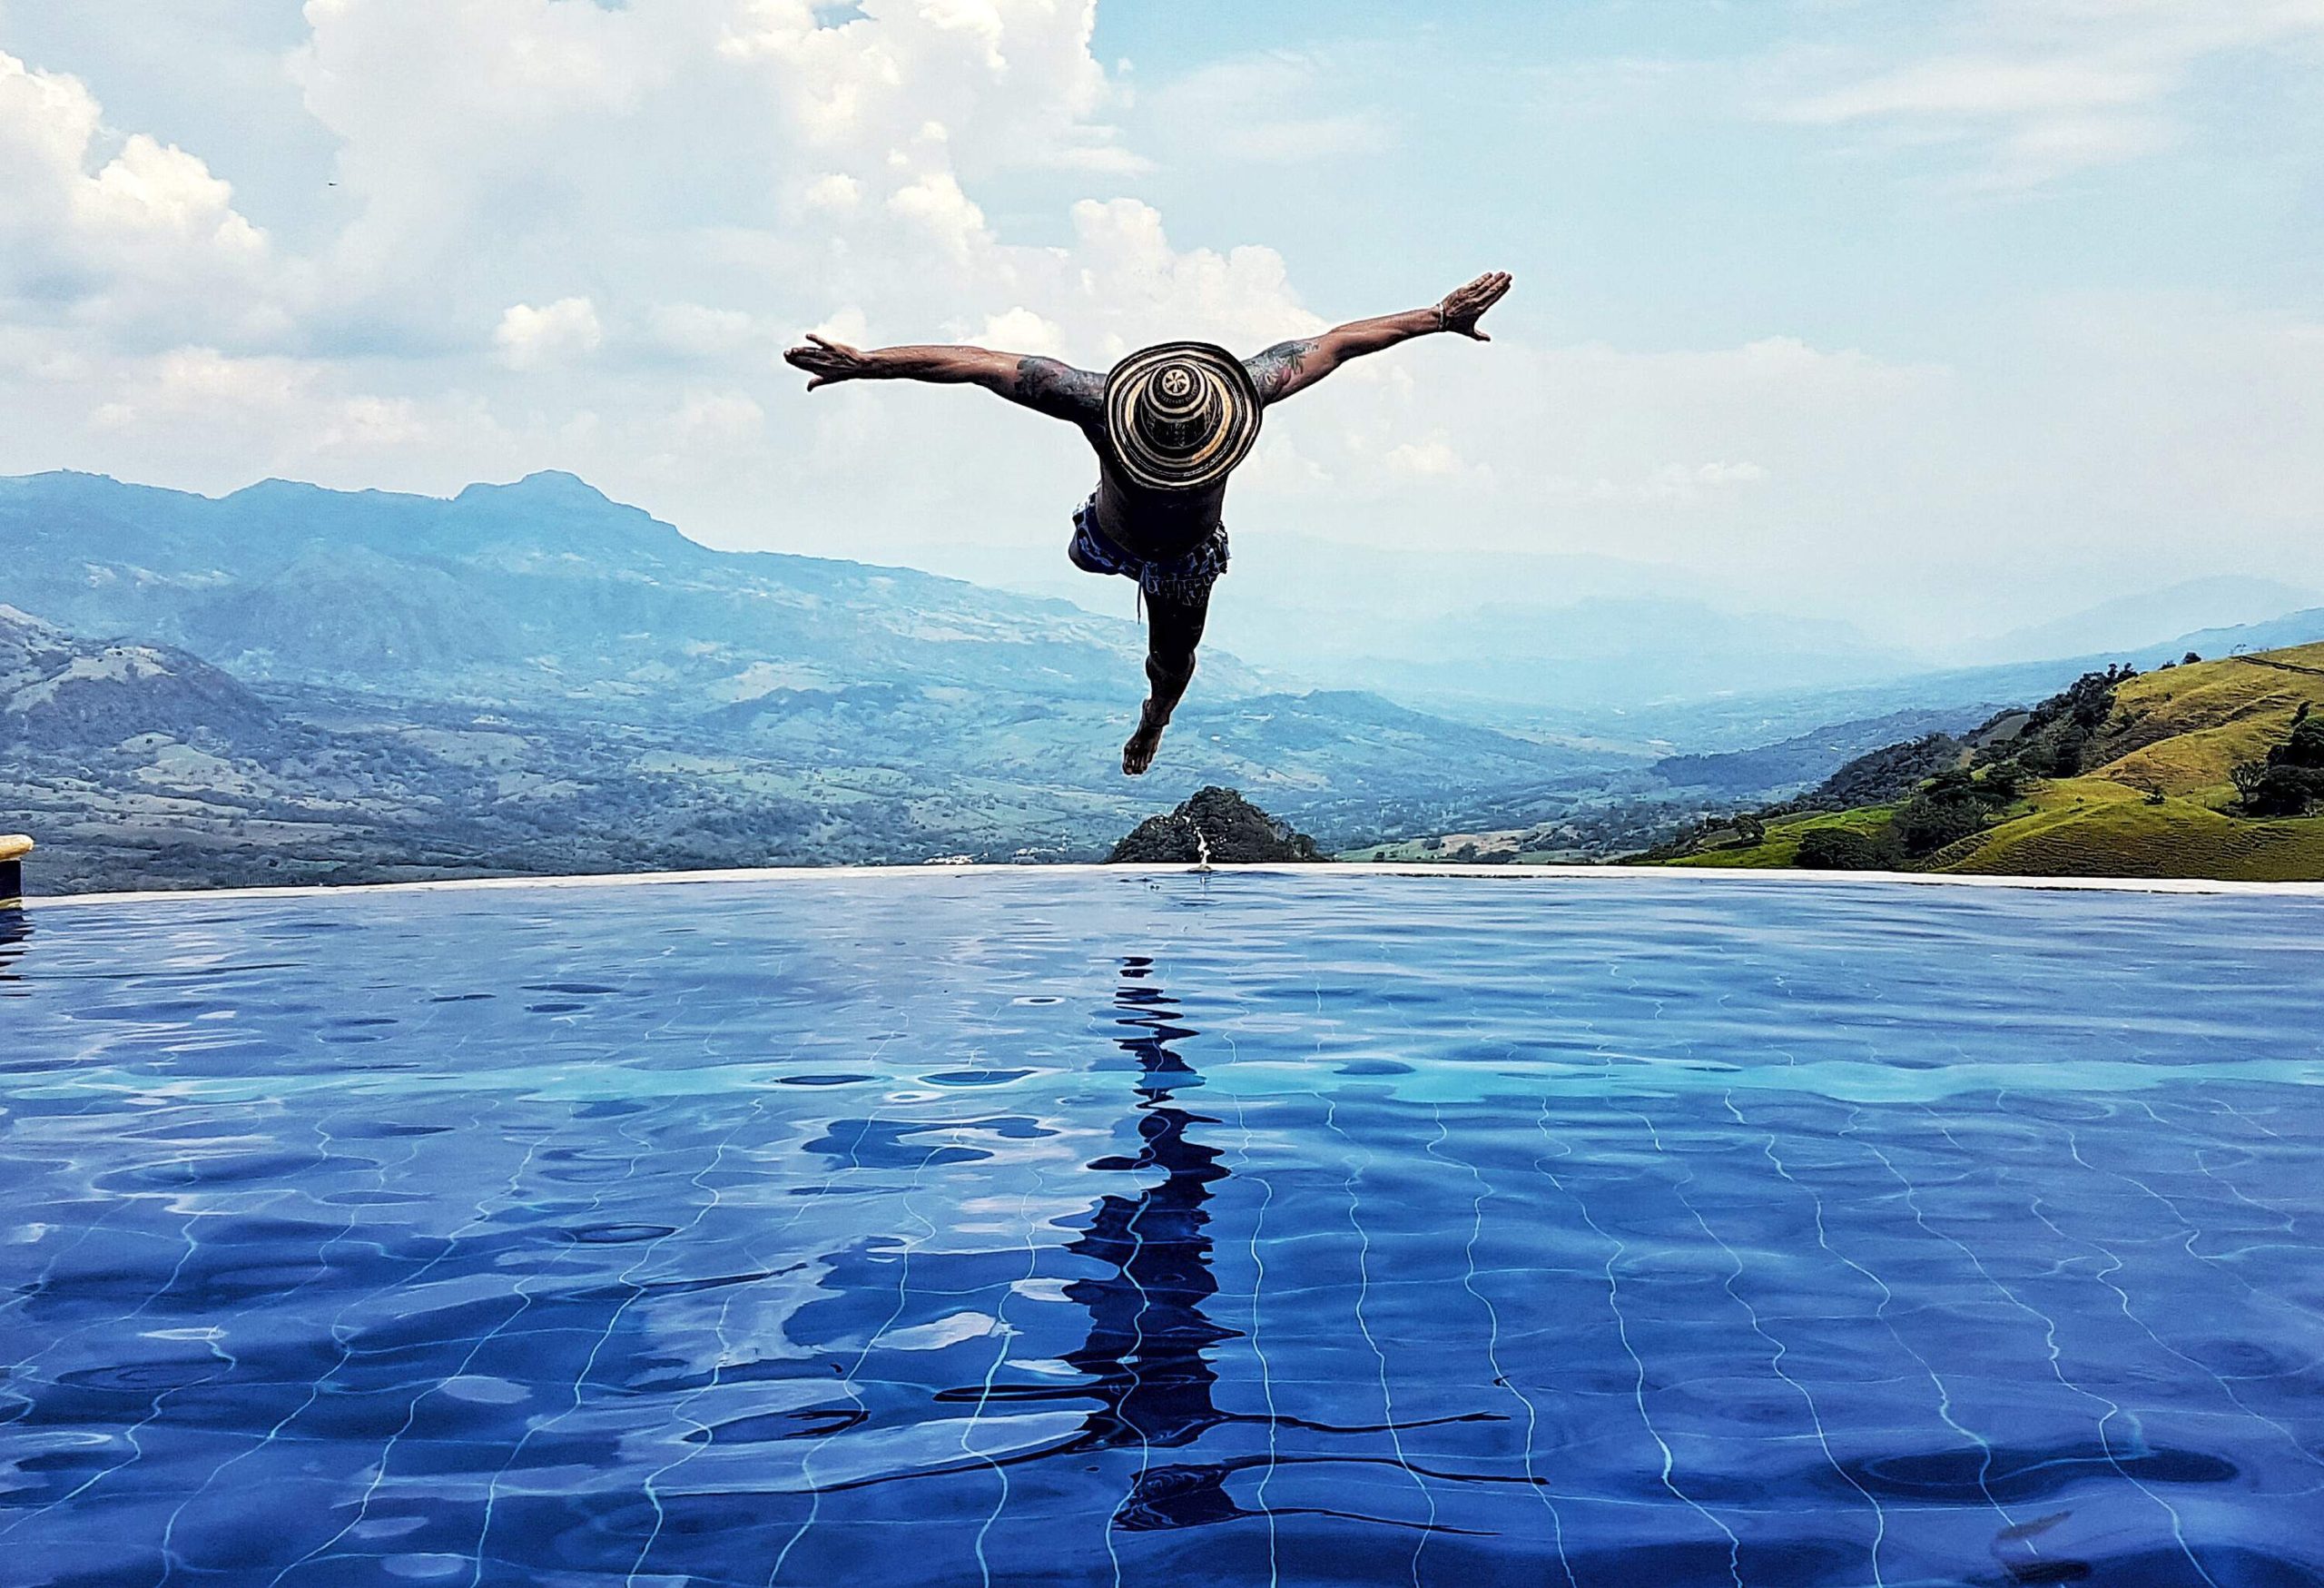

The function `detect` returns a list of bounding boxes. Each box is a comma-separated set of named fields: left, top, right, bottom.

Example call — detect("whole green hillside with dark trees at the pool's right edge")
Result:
left=1640, top=644, right=2324, bottom=882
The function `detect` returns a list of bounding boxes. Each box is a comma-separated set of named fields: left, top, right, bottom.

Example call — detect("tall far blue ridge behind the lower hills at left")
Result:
left=0, top=474, right=1257, bottom=712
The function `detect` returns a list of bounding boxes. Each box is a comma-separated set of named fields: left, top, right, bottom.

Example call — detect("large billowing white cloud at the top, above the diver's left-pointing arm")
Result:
left=266, top=0, right=1171, bottom=358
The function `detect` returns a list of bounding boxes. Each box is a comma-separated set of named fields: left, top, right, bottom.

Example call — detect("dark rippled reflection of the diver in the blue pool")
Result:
left=937, top=953, right=1497, bottom=1533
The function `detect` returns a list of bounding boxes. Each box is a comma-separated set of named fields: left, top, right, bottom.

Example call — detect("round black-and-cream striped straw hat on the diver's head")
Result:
left=1107, top=341, right=1260, bottom=490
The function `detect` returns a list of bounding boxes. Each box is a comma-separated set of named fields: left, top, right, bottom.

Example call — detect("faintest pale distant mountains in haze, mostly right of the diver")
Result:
left=948, top=530, right=2324, bottom=715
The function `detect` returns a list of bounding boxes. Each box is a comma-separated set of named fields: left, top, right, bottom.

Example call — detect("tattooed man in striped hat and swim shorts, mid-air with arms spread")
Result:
left=783, top=270, right=1511, bottom=776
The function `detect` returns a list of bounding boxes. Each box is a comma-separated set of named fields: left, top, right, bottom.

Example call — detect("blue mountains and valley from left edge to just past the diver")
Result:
left=0, top=474, right=1620, bottom=886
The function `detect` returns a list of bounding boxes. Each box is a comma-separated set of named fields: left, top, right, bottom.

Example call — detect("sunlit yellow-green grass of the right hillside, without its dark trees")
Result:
left=1676, top=644, right=2324, bottom=882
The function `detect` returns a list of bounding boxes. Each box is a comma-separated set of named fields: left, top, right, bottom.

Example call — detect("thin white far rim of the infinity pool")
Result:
left=25, top=860, right=2324, bottom=909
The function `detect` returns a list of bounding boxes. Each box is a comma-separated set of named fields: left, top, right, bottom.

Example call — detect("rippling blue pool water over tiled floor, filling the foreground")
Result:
left=0, top=872, right=2324, bottom=1588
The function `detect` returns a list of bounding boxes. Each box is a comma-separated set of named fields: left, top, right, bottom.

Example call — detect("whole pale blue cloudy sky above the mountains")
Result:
left=0, top=0, right=2324, bottom=644
